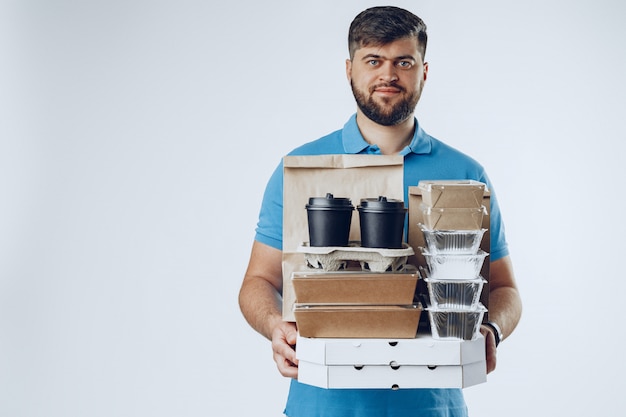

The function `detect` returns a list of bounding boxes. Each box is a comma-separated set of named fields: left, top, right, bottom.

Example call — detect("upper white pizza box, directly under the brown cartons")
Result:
left=296, top=333, right=485, bottom=366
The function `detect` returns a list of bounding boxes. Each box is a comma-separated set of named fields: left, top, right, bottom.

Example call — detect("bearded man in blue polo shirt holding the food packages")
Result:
left=239, top=7, right=521, bottom=417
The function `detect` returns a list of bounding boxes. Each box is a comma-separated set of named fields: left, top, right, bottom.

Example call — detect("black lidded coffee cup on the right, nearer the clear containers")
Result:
left=358, top=196, right=407, bottom=249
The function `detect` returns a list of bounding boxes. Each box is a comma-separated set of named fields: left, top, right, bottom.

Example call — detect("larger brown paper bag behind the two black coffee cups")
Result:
left=283, top=155, right=407, bottom=321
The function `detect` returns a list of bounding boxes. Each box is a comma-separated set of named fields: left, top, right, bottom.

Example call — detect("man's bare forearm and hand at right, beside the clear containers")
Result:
left=481, top=256, right=522, bottom=372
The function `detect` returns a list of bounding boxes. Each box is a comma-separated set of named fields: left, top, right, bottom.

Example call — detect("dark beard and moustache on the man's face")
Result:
left=350, top=81, right=421, bottom=126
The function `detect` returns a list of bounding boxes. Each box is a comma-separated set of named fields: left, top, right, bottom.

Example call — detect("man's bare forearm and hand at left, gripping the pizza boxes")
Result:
left=239, top=241, right=298, bottom=378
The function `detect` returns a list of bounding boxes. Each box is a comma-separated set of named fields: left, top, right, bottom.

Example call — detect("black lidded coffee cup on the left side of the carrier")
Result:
left=306, top=193, right=354, bottom=246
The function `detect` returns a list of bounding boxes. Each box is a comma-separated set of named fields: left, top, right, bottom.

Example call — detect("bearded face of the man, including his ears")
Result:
left=346, top=38, right=428, bottom=126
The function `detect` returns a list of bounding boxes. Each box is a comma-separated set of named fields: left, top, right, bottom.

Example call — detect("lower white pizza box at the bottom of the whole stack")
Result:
left=298, top=361, right=487, bottom=389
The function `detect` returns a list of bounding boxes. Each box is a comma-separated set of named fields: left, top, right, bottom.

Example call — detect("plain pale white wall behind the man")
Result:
left=0, top=0, right=626, bottom=417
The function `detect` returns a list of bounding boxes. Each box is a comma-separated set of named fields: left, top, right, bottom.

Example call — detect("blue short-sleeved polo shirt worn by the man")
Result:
left=255, top=115, right=508, bottom=417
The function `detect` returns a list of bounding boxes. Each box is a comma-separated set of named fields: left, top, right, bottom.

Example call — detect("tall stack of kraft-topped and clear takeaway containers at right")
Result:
left=418, top=181, right=488, bottom=340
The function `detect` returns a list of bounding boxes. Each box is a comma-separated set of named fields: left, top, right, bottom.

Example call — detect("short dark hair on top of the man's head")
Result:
left=348, top=6, right=428, bottom=59
